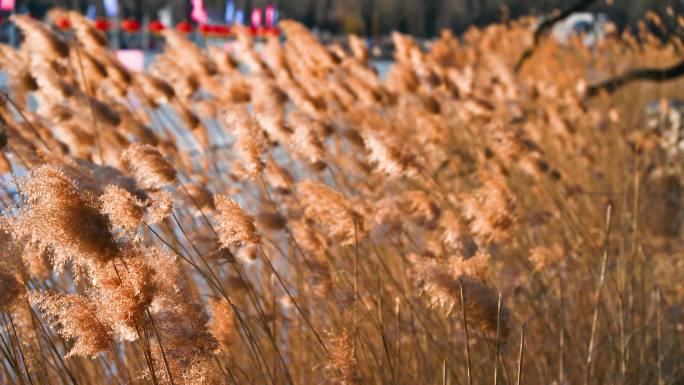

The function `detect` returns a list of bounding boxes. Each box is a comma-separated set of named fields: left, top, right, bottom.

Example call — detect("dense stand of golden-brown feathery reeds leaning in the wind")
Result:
left=0, top=10, right=684, bottom=385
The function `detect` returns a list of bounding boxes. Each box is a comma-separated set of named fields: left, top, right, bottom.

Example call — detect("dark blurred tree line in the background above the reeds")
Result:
left=16, top=0, right=684, bottom=37
